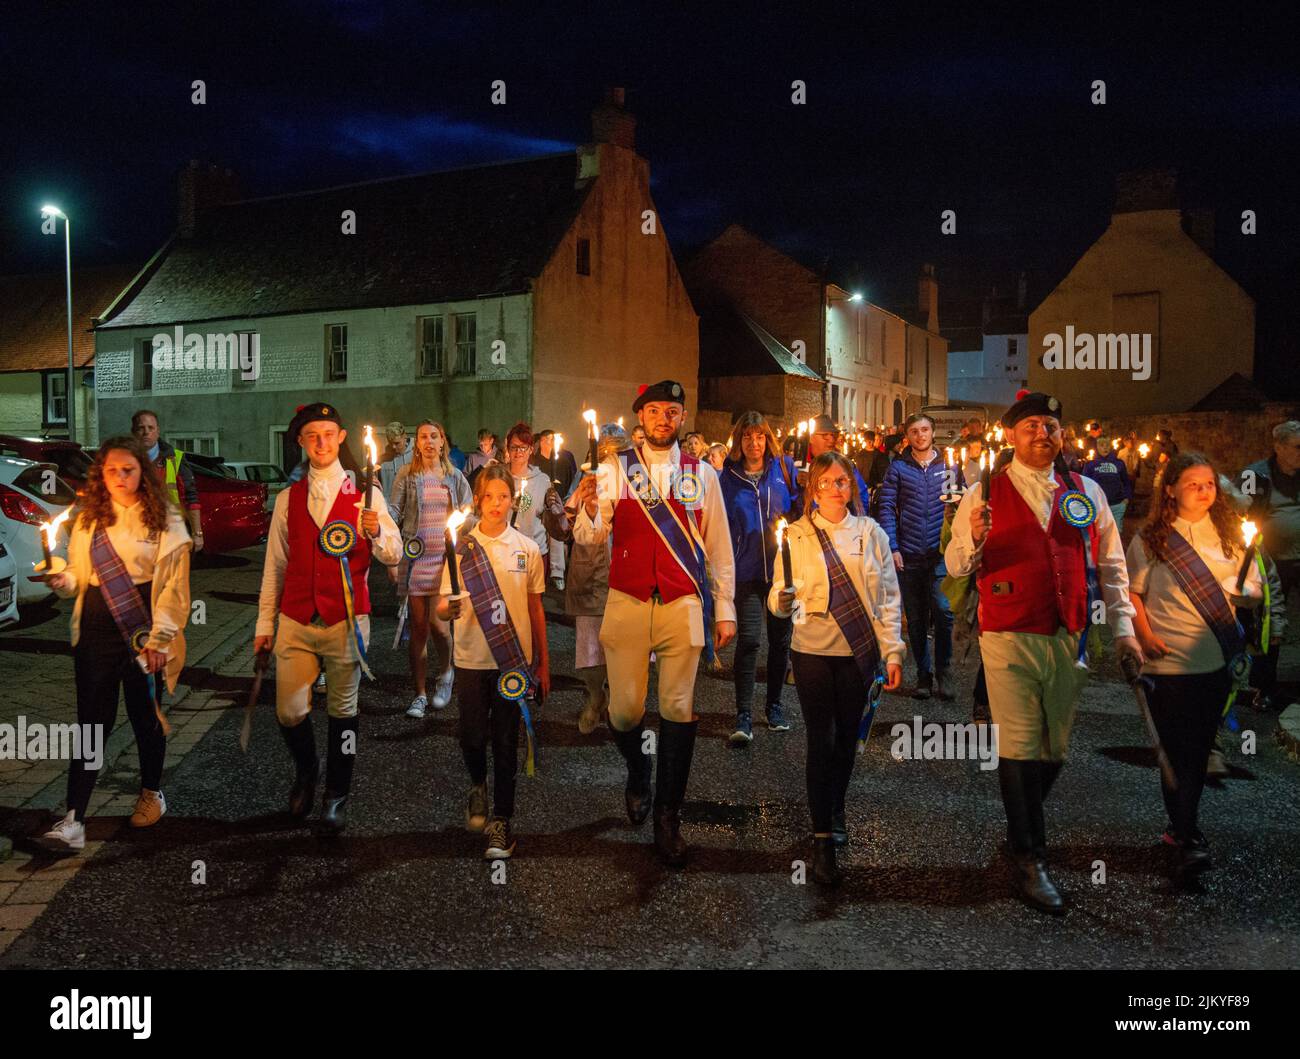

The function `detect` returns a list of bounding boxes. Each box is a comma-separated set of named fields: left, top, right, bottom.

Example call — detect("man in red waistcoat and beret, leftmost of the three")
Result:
left=254, top=403, right=402, bottom=834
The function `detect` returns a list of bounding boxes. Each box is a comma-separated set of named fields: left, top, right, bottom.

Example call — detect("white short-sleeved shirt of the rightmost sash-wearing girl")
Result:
left=1128, top=516, right=1264, bottom=673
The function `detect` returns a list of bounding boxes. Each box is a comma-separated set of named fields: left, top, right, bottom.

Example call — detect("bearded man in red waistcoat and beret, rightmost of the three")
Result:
left=944, top=390, right=1143, bottom=913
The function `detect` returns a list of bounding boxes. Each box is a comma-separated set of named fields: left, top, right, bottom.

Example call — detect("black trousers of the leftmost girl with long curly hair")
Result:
left=68, top=583, right=166, bottom=823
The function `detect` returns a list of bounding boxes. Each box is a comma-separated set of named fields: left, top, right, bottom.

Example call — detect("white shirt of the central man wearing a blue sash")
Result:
left=573, top=442, right=736, bottom=621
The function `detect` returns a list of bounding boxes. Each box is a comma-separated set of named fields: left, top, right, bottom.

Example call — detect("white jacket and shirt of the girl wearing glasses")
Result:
left=767, top=511, right=906, bottom=665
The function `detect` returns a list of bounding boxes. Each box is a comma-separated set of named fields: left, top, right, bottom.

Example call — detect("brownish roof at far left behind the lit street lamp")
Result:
left=0, top=265, right=138, bottom=373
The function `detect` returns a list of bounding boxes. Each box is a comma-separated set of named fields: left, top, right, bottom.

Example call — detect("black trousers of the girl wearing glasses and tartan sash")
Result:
left=790, top=651, right=867, bottom=834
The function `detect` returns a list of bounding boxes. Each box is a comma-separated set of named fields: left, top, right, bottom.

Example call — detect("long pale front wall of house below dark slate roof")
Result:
left=95, top=295, right=532, bottom=463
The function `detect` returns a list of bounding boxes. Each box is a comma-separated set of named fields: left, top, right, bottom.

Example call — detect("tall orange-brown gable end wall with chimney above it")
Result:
left=530, top=143, right=699, bottom=447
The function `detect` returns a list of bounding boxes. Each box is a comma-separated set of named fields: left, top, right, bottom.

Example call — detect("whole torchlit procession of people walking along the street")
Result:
left=30, top=389, right=1300, bottom=912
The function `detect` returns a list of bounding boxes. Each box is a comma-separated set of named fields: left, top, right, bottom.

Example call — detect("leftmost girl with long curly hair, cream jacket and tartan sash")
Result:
left=39, top=437, right=192, bottom=852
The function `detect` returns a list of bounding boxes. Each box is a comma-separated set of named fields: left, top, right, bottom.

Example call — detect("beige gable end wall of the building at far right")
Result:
left=1028, top=209, right=1255, bottom=417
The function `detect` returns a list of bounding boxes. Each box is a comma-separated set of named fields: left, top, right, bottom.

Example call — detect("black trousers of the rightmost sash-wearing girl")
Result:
left=1147, top=667, right=1232, bottom=842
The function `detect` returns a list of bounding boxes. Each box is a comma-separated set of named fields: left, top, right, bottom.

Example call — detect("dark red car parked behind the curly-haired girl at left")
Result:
left=0, top=434, right=270, bottom=555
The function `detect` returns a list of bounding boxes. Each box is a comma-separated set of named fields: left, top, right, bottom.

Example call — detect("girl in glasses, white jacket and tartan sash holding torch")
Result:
left=767, top=451, right=906, bottom=886
